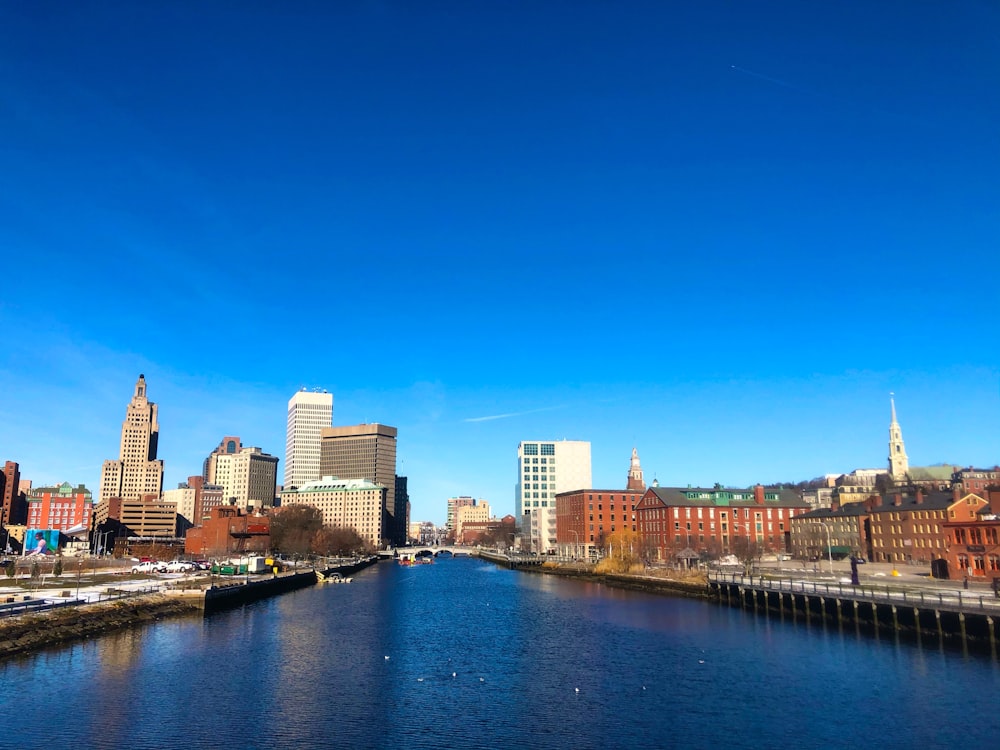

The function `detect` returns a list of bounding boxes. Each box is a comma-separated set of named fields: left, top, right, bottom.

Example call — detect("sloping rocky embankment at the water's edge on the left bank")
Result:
left=0, top=594, right=201, bottom=657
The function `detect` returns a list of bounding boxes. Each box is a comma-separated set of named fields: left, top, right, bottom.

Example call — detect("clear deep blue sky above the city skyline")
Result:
left=0, top=0, right=1000, bottom=522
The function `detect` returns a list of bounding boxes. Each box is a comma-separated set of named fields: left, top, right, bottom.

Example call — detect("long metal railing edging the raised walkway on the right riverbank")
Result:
left=708, top=573, right=1000, bottom=615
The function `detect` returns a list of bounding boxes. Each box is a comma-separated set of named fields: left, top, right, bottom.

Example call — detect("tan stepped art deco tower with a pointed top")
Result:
left=100, top=375, right=163, bottom=501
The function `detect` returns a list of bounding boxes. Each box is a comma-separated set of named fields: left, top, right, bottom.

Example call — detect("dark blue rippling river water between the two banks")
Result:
left=0, top=558, right=1000, bottom=750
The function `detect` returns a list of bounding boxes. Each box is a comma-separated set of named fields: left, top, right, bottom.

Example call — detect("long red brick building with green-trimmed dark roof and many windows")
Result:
left=635, top=482, right=809, bottom=561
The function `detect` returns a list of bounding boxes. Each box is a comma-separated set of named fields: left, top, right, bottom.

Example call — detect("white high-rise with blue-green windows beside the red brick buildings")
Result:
left=514, top=440, right=593, bottom=554
